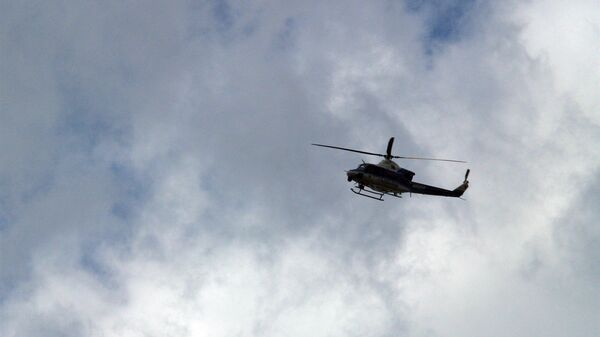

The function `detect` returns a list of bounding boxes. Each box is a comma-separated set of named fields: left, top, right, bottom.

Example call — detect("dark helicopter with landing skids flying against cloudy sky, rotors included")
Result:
left=312, top=137, right=470, bottom=201
